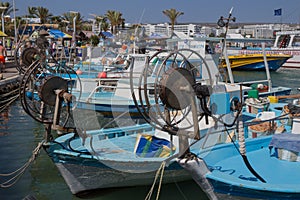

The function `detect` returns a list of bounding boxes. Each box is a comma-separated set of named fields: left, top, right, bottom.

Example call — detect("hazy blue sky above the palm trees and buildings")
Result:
left=12, top=0, right=300, bottom=23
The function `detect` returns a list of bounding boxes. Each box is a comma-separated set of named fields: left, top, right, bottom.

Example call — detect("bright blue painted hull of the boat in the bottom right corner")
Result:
left=202, top=136, right=300, bottom=199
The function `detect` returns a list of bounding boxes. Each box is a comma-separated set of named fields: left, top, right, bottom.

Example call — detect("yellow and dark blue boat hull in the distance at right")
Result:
left=222, top=54, right=292, bottom=71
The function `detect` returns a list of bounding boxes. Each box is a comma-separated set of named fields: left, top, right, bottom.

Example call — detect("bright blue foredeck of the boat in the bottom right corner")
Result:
left=207, top=136, right=300, bottom=197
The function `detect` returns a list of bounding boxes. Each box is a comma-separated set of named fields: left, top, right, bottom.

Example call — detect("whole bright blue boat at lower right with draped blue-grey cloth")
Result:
left=183, top=115, right=300, bottom=199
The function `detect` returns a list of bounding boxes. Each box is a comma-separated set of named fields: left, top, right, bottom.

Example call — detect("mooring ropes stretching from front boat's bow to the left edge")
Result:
left=0, top=141, right=44, bottom=188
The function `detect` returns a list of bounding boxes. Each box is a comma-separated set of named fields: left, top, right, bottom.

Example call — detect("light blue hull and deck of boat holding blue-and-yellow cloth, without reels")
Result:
left=44, top=124, right=191, bottom=194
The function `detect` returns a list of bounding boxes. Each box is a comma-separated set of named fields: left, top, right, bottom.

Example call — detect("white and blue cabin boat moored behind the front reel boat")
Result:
left=73, top=38, right=291, bottom=117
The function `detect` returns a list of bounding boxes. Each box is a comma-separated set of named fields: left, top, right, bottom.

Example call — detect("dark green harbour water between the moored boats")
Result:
left=0, top=69, right=300, bottom=200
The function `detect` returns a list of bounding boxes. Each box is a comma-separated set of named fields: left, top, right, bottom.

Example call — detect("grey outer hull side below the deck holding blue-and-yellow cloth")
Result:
left=55, top=161, right=191, bottom=194
